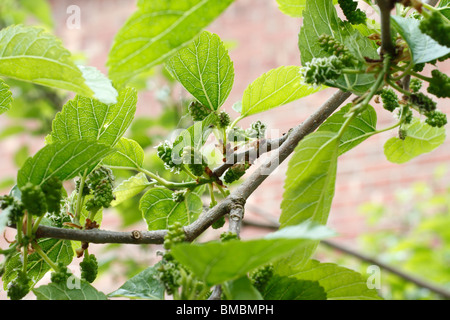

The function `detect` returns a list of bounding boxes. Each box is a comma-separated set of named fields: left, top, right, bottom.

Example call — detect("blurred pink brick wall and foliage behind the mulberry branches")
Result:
left=0, top=0, right=450, bottom=299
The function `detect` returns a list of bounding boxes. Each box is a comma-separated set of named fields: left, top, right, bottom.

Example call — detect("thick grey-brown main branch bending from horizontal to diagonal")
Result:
left=32, top=90, right=351, bottom=244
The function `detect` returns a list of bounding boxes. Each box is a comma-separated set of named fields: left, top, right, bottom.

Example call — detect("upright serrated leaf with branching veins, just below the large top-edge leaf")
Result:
left=167, top=31, right=234, bottom=110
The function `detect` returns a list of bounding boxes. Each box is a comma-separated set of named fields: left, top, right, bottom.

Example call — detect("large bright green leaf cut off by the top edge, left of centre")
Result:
left=107, top=0, right=233, bottom=86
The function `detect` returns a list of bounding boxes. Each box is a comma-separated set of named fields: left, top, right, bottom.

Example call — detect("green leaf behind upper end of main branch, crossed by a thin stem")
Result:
left=317, top=103, right=377, bottom=155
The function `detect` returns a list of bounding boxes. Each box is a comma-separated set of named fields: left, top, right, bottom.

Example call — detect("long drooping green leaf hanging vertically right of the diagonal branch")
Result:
left=280, top=131, right=339, bottom=265
